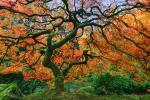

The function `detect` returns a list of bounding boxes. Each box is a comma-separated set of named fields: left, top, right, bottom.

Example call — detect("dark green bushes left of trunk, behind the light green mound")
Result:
left=0, top=73, right=48, bottom=94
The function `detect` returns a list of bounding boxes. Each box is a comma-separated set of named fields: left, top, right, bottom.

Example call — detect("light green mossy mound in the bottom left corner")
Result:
left=0, top=83, right=23, bottom=100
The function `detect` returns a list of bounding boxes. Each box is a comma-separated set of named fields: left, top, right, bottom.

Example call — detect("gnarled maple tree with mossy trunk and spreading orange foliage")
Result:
left=0, top=0, right=150, bottom=90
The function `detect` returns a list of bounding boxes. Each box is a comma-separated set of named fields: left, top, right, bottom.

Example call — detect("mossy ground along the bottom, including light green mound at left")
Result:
left=0, top=83, right=150, bottom=100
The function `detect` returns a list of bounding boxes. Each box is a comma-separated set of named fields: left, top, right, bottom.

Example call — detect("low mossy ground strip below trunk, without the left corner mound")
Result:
left=24, top=91, right=150, bottom=100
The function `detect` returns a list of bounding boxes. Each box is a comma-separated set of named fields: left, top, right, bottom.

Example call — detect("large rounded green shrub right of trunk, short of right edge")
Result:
left=88, top=73, right=133, bottom=95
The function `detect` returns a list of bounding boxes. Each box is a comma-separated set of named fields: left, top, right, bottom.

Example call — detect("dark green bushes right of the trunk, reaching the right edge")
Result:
left=87, top=72, right=150, bottom=95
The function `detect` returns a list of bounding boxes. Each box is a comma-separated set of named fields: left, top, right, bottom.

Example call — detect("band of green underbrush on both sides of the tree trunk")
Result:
left=0, top=72, right=150, bottom=97
